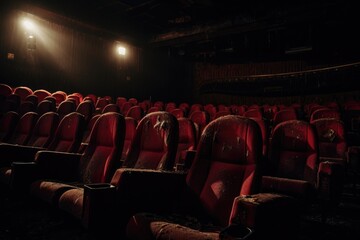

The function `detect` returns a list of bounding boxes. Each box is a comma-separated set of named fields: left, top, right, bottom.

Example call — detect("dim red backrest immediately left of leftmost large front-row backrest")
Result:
left=47, top=112, right=86, bottom=152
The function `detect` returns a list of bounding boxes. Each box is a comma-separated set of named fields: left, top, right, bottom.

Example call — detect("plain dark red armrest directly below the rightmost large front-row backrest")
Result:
left=261, top=176, right=315, bottom=200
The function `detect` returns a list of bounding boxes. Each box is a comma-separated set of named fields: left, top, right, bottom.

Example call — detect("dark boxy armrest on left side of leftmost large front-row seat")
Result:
left=35, top=151, right=82, bottom=182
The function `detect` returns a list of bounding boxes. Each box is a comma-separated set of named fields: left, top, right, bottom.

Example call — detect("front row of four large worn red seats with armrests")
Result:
left=0, top=111, right=342, bottom=239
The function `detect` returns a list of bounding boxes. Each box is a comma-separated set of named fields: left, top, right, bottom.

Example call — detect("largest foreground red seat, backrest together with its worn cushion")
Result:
left=126, top=115, right=262, bottom=239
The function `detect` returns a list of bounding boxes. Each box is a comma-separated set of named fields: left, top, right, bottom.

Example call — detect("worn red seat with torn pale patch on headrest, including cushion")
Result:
left=58, top=111, right=179, bottom=232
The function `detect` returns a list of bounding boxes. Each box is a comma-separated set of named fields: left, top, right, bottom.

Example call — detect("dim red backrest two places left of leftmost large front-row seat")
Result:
left=27, top=112, right=60, bottom=148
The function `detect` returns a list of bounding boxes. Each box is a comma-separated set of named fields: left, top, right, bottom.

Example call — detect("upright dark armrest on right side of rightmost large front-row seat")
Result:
left=318, top=161, right=345, bottom=205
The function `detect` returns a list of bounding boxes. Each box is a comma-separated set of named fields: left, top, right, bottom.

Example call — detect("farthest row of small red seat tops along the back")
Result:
left=0, top=84, right=360, bottom=120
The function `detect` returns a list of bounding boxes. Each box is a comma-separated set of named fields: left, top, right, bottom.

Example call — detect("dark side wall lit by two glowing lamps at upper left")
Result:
left=0, top=9, right=192, bottom=102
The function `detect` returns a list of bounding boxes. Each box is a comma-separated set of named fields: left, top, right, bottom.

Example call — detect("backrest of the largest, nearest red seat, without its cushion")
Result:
left=183, top=115, right=262, bottom=226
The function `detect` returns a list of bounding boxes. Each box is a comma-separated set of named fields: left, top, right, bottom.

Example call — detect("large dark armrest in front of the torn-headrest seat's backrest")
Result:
left=111, top=168, right=186, bottom=213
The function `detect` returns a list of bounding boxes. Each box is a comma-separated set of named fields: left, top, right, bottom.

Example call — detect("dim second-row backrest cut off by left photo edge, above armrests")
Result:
left=0, top=111, right=20, bottom=142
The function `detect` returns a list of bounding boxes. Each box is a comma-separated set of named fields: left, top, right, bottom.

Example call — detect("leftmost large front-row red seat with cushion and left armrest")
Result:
left=30, top=112, right=125, bottom=206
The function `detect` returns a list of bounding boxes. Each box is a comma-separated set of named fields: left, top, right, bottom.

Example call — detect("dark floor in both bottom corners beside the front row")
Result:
left=0, top=182, right=360, bottom=240
